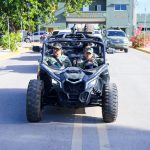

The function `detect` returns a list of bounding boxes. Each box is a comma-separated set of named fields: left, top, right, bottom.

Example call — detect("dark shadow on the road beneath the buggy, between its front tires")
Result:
left=42, top=107, right=103, bottom=124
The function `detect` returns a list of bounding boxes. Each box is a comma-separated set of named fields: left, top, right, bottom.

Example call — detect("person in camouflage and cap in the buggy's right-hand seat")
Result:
left=80, top=46, right=102, bottom=69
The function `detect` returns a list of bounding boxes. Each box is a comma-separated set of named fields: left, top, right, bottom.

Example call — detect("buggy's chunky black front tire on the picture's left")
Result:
left=26, top=80, right=44, bottom=122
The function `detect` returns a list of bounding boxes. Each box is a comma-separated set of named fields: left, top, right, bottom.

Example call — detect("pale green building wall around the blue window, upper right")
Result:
left=106, top=0, right=135, bottom=35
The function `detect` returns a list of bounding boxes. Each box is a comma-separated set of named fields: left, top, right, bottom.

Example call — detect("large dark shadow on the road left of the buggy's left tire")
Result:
left=0, top=89, right=27, bottom=124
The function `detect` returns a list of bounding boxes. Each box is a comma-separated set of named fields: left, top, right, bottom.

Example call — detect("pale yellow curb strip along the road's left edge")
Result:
left=0, top=48, right=31, bottom=61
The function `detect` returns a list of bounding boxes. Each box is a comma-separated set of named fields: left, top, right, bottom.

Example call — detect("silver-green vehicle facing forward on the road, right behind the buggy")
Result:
left=104, top=29, right=129, bottom=53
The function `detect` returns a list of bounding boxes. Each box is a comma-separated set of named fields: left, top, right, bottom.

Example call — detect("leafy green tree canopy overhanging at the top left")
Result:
left=0, top=0, right=92, bottom=32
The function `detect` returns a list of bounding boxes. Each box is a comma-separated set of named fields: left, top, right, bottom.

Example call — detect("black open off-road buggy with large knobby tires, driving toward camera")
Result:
left=26, top=39, right=118, bottom=122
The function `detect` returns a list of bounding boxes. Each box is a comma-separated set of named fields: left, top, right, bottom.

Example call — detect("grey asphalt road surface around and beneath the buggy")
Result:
left=0, top=49, right=150, bottom=150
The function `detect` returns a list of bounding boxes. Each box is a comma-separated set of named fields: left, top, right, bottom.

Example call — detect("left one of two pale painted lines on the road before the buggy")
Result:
left=71, top=116, right=82, bottom=150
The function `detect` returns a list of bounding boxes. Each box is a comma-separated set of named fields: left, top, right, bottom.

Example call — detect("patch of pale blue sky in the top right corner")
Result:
left=137, top=0, right=150, bottom=13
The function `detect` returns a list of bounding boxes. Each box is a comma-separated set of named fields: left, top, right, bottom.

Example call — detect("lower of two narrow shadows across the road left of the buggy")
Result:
left=0, top=65, right=37, bottom=73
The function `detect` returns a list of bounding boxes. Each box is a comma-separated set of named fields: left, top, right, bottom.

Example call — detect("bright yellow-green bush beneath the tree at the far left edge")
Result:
left=0, top=32, right=21, bottom=51
